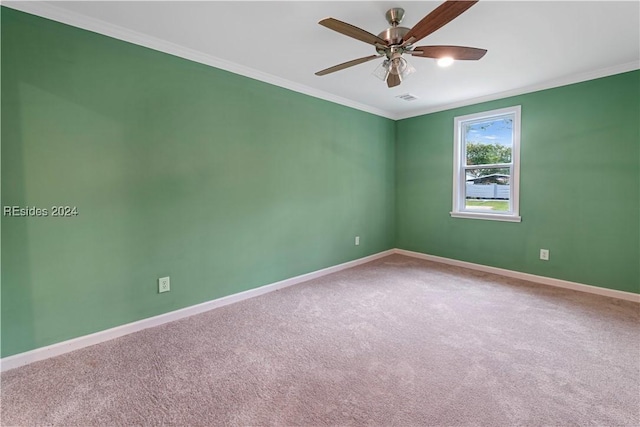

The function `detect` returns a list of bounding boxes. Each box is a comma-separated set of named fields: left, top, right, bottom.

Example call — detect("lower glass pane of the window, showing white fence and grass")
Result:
left=465, top=168, right=511, bottom=212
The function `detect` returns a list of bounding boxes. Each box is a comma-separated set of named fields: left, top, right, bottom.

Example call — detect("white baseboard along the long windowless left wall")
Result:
left=0, top=249, right=394, bottom=372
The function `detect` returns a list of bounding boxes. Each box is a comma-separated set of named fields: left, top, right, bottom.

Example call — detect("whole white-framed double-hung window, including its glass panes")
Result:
left=451, top=106, right=520, bottom=222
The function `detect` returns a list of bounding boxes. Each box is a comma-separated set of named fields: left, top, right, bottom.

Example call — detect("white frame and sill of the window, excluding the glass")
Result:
left=450, top=105, right=522, bottom=222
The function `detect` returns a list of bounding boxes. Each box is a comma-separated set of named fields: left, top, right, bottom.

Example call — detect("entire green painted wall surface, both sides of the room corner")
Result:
left=1, top=7, right=640, bottom=357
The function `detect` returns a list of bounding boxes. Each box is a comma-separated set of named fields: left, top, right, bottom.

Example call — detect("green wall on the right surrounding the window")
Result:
left=396, top=71, right=640, bottom=292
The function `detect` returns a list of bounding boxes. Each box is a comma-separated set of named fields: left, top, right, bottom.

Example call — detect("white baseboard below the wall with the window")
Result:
left=393, top=249, right=640, bottom=302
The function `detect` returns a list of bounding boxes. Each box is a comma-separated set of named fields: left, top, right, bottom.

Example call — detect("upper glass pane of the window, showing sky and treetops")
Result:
left=464, top=115, right=513, bottom=165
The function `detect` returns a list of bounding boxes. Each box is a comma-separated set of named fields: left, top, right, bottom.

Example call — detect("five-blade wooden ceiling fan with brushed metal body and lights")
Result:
left=316, top=0, right=487, bottom=88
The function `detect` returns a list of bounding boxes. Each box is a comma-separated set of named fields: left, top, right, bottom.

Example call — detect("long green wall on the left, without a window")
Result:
left=2, top=8, right=395, bottom=357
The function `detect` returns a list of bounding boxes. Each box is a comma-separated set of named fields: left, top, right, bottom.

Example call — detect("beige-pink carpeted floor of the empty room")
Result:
left=1, top=255, right=640, bottom=426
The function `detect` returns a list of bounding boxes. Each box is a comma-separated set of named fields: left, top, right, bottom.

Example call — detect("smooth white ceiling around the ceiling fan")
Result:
left=3, top=0, right=640, bottom=119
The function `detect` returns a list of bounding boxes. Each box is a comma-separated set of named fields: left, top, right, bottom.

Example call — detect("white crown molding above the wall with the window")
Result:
left=394, top=61, right=640, bottom=120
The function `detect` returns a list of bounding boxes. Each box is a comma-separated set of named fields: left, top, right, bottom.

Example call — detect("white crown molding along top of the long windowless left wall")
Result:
left=2, top=1, right=395, bottom=120
